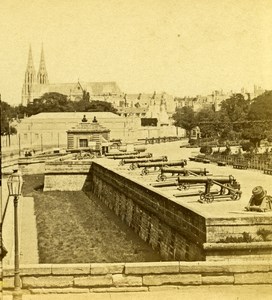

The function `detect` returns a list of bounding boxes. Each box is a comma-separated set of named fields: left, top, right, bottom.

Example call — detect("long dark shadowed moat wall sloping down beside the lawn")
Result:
left=91, top=163, right=206, bottom=261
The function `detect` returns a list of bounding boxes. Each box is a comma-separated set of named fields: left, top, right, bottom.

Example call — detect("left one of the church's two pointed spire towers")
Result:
left=22, top=46, right=36, bottom=106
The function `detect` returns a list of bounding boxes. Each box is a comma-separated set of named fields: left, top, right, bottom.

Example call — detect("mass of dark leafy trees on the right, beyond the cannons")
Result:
left=173, top=91, right=272, bottom=147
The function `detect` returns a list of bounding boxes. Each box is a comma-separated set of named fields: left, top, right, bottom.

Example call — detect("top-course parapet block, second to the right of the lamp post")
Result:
left=52, top=264, right=91, bottom=275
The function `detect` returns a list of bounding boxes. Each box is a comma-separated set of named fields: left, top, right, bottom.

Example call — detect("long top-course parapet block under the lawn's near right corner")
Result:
left=125, top=261, right=179, bottom=274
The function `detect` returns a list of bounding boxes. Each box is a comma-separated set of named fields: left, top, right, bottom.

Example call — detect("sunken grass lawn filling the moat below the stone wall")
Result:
left=23, top=175, right=161, bottom=263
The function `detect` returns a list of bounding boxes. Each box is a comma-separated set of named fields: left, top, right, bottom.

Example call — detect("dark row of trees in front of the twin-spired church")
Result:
left=1, top=92, right=117, bottom=135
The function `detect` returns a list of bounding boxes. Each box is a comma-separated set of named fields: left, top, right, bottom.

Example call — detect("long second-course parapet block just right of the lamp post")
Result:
left=22, top=276, right=73, bottom=288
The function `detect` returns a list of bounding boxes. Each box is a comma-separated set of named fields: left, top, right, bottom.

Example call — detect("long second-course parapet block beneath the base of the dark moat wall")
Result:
left=143, top=274, right=202, bottom=285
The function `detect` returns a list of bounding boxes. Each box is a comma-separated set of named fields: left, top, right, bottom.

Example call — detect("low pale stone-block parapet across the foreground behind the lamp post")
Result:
left=3, top=261, right=272, bottom=294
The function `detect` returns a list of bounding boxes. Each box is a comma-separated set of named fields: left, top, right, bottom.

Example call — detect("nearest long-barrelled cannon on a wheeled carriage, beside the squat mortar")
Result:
left=178, top=175, right=242, bottom=203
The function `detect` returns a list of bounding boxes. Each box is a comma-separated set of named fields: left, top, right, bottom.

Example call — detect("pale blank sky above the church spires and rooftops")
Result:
left=0, top=0, right=272, bottom=105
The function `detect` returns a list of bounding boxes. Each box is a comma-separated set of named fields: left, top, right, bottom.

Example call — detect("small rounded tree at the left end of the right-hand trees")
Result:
left=173, top=106, right=196, bottom=138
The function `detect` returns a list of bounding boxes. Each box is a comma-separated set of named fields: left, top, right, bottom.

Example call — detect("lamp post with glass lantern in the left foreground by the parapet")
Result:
left=7, top=170, right=23, bottom=300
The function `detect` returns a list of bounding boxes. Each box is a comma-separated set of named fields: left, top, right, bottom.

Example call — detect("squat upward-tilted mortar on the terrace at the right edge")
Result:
left=245, top=186, right=272, bottom=212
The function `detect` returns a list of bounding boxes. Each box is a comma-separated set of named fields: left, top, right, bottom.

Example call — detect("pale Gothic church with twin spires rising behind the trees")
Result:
left=22, top=46, right=122, bottom=106
